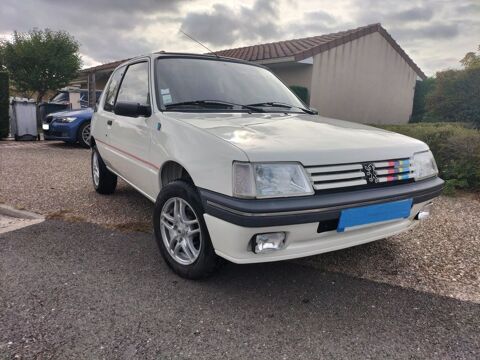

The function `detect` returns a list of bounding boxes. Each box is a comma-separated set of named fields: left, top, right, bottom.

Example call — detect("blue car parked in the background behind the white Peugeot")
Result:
left=42, top=108, right=93, bottom=148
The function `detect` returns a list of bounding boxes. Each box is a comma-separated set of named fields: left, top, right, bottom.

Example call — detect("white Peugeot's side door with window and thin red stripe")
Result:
left=107, top=60, right=158, bottom=194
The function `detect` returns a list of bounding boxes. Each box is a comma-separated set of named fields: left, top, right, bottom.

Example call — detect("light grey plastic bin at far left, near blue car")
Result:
left=11, top=100, right=38, bottom=140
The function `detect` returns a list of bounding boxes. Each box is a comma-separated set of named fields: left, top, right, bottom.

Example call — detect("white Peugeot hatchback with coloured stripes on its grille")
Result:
left=91, top=53, right=443, bottom=278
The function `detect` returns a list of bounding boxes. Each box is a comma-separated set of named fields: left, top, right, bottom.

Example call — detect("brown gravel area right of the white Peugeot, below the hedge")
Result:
left=298, top=194, right=480, bottom=303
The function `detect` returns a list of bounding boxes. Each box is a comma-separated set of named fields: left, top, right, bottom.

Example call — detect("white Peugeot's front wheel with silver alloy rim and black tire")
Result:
left=153, top=180, right=224, bottom=279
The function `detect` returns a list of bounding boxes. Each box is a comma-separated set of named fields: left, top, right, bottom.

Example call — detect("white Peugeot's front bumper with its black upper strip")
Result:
left=200, top=178, right=444, bottom=263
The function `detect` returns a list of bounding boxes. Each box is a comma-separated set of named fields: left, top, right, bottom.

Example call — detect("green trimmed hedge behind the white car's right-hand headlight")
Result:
left=376, top=123, right=480, bottom=193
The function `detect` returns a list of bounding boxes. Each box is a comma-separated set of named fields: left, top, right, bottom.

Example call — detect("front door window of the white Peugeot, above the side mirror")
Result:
left=117, top=62, right=150, bottom=105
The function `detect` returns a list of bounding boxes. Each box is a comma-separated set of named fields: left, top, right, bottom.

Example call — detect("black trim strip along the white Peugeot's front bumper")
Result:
left=200, top=177, right=444, bottom=227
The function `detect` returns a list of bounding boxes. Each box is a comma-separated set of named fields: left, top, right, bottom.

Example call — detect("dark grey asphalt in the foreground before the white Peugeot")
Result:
left=0, top=220, right=480, bottom=359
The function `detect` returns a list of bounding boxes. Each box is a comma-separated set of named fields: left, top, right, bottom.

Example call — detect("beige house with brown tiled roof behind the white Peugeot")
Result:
left=78, top=24, right=426, bottom=124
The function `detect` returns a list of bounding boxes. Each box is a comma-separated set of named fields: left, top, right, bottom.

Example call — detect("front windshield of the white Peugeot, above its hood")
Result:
left=156, top=58, right=305, bottom=112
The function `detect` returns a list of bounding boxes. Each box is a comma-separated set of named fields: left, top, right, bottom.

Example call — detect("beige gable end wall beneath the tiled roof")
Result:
left=310, top=32, right=417, bottom=124
